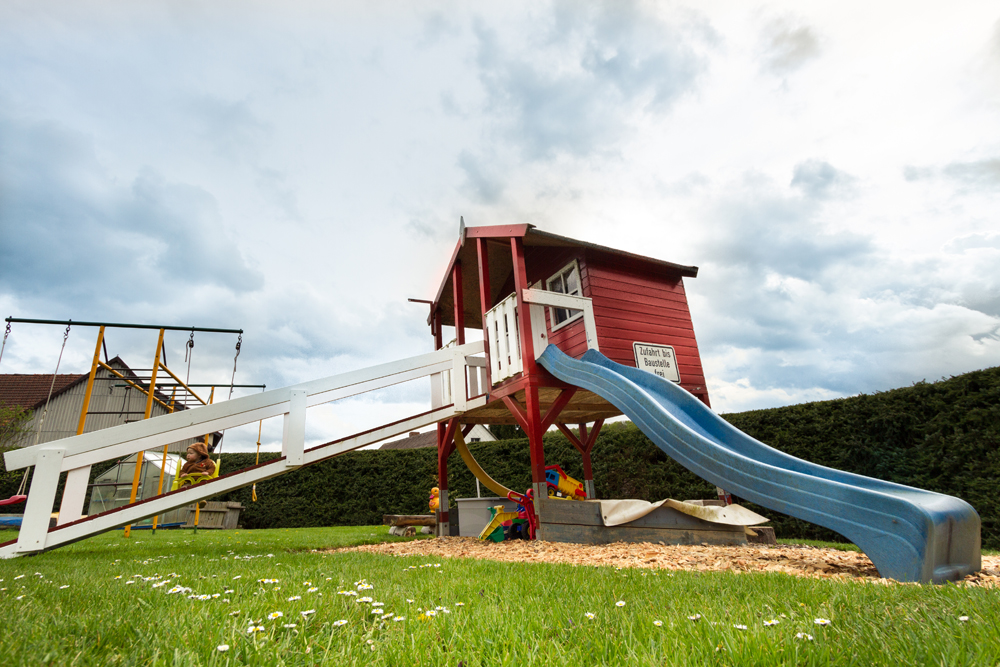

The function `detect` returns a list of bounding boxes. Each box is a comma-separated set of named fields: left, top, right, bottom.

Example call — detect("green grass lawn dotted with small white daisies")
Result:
left=0, top=526, right=1000, bottom=667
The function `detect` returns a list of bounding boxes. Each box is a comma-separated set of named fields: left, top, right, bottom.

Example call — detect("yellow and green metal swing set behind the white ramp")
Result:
left=0, top=317, right=265, bottom=537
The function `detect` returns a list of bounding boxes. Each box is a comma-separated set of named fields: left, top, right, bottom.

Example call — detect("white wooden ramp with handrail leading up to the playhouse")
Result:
left=0, top=341, right=486, bottom=558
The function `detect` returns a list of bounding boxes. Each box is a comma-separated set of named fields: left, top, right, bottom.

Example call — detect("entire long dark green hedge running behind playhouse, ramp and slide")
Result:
left=0, top=368, right=1000, bottom=549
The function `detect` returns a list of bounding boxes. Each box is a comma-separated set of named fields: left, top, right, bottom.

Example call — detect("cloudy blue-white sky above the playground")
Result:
left=0, top=0, right=1000, bottom=451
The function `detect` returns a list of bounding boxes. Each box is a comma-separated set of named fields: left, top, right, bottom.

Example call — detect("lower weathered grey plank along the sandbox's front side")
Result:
left=538, top=521, right=747, bottom=546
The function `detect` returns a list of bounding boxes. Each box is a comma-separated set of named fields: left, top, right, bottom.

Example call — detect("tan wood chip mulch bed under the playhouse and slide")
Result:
left=330, top=537, right=1000, bottom=588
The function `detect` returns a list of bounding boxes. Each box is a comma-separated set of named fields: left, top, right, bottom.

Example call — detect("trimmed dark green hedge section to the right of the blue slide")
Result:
left=724, top=367, right=1000, bottom=549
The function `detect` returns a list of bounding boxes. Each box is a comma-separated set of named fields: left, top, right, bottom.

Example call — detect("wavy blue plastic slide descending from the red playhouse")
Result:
left=538, top=345, right=981, bottom=583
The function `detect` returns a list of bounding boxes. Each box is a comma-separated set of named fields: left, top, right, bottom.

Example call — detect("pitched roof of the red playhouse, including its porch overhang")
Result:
left=428, top=224, right=698, bottom=327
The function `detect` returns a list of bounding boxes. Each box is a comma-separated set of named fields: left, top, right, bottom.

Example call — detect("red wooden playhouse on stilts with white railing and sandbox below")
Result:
left=428, top=224, right=746, bottom=543
